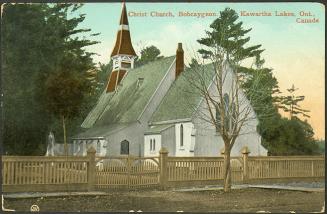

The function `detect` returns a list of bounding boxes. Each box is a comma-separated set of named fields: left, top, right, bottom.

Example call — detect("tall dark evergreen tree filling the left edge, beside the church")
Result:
left=1, top=4, right=95, bottom=155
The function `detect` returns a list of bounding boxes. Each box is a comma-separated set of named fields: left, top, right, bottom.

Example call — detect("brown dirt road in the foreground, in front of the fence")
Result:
left=4, top=188, right=325, bottom=213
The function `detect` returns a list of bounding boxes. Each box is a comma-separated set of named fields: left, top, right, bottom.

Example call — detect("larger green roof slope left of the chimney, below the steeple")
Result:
left=82, top=56, right=175, bottom=128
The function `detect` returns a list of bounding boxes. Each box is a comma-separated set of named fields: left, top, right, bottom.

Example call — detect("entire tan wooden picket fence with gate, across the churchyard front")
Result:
left=2, top=148, right=325, bottom=192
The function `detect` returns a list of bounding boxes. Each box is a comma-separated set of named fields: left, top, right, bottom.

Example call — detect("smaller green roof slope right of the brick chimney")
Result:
left=150, top=64, right=215, bottom=123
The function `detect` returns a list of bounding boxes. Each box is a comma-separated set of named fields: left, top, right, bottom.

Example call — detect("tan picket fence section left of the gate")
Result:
left=2, top=156, right=89, bottom=191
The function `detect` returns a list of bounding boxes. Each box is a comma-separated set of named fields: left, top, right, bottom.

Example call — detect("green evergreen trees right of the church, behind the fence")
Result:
left=239, top=59, right=318, bottom=155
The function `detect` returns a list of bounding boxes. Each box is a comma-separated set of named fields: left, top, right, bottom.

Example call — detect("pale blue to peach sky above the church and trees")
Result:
left=75, top=3, right=325, bottom=139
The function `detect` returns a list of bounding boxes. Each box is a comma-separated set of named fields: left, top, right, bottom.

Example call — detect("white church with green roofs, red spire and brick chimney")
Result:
left=59, top=3, right=267, bottom=157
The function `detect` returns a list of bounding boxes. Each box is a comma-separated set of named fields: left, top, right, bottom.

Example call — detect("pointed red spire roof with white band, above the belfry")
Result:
left=111, top=2, right=136, bottom=56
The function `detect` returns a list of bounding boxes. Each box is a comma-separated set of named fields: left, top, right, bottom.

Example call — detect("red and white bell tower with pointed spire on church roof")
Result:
left=107, top=2, right=137, bottom=92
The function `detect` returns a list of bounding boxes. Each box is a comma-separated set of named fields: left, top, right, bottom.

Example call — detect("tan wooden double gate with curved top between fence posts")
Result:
left=96, top=156, right=159, bottom=189
